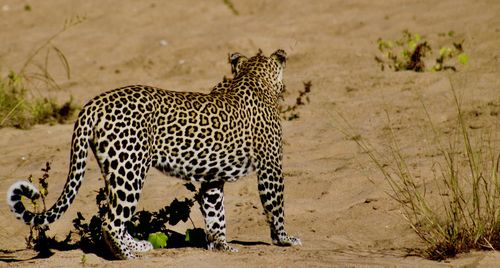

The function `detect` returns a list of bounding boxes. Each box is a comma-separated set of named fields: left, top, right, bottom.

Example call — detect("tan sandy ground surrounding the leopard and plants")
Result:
left=0, top=0, right=500, bottom=267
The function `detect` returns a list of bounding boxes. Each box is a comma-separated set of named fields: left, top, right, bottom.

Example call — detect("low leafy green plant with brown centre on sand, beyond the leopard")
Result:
left=375, top=30, right=469, bottom=72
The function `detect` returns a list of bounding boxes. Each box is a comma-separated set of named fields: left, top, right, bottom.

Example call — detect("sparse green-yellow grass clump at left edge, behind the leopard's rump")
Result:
left=0, top=17, right=84, bottom=128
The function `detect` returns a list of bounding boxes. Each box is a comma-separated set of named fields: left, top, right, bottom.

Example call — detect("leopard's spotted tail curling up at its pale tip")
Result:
left=7, top=107, right=92, bottom=226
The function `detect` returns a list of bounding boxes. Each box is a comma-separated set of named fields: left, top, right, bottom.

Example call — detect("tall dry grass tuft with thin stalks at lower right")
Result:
left=342, top=85, right=500, bottom=260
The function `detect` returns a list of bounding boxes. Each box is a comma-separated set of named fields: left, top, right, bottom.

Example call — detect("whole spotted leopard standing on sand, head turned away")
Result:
left=7, top=49, right=302, bottom=259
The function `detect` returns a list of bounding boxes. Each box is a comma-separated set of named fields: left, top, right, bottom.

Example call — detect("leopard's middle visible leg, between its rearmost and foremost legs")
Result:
left=198, top=182, right=238, bottom=252
